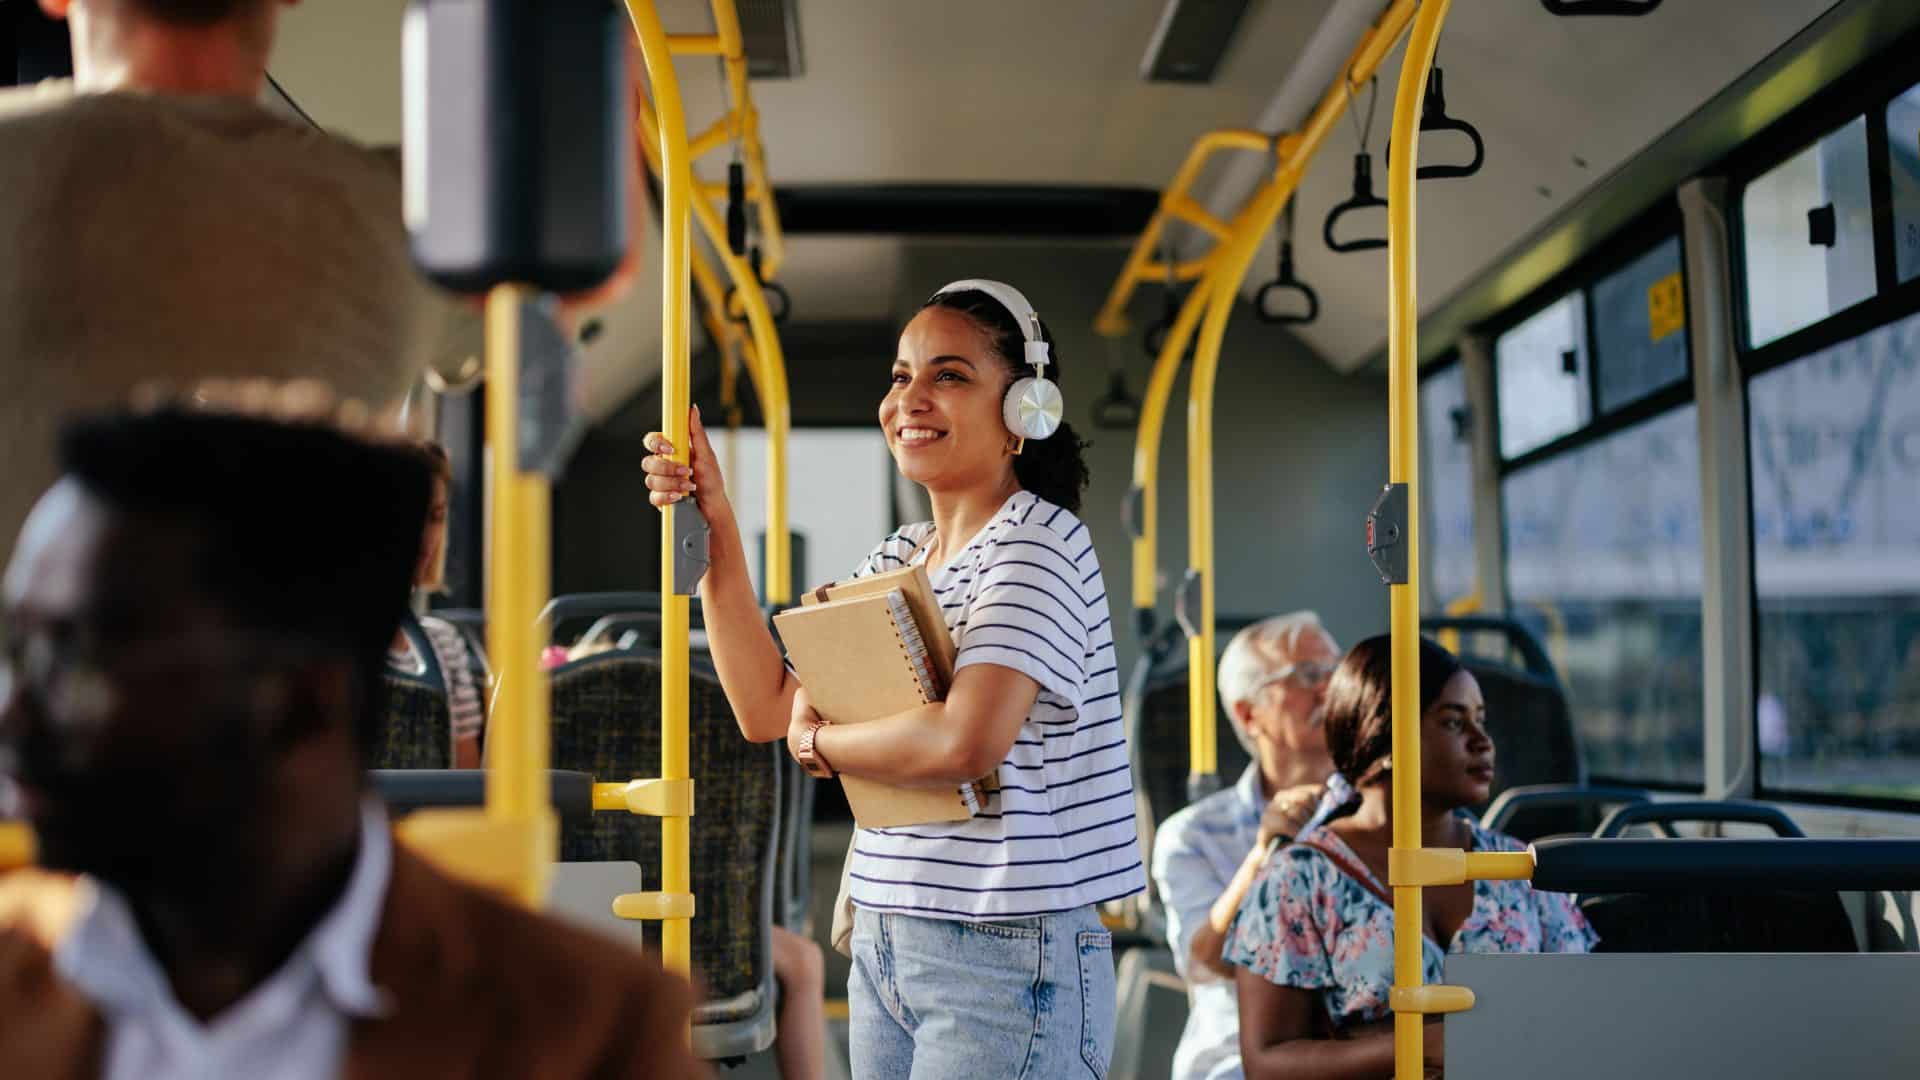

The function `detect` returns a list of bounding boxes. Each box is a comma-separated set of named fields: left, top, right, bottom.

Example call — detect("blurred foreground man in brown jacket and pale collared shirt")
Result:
left=0, top=409, right=701, bottom=1080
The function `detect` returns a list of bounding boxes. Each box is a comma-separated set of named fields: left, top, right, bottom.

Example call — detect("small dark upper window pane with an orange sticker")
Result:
left=1592, top=236, right=1686, bottom=413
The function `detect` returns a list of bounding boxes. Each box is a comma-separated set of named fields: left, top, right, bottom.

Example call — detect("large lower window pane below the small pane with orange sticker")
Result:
left=1501, top=405, right=1703, bottom=784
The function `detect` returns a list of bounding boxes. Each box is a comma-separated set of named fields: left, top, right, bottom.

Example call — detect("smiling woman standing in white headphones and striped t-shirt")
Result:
left=645, top=281, right=1146, bottom=1076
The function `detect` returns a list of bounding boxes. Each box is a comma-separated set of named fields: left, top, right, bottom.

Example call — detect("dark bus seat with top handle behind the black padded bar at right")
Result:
left=1580, top=799, right=1859, bottom=953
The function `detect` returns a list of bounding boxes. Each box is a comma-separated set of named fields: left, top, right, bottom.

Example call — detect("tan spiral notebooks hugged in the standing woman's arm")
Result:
left=774, top=567, right=991, bottom=828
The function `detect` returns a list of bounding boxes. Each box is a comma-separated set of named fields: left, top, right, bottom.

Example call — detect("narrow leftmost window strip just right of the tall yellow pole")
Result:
left=1421, top=363, right=1476, bottom=607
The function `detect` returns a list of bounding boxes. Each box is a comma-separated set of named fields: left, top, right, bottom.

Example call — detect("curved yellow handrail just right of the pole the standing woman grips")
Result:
left=637, top=90, right=793, bottom=607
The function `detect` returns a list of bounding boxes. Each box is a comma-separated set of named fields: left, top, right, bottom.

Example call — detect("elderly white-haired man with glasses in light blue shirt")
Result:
left=1154, top=611, right=1352, bottom=1080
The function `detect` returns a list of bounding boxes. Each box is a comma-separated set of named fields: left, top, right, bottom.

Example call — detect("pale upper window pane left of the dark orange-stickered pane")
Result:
left=1494, top=292, right=1594, bottom=461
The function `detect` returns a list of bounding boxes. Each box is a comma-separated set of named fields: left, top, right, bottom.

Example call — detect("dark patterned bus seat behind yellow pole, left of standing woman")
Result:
left=551, top=650, right=785, bottom=1061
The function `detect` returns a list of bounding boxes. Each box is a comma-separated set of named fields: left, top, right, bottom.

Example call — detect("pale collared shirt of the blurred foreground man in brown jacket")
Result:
left=54, top=799, right=394, bottom=1080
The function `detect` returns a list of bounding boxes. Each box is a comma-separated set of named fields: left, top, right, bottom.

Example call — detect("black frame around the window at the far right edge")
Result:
left=1722, top=63, right=1920, bottom=813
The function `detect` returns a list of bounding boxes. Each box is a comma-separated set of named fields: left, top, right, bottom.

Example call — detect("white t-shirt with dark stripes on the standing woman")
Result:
left=849, top=492, right=1146, bottom=919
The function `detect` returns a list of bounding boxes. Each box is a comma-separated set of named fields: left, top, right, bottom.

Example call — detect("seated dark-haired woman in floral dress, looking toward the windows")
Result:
left=1225, top=636, right=1597, bottom=1078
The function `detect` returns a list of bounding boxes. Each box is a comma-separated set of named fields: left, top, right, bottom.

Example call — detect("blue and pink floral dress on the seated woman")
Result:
left=1221, top=822, right=1599, bottom=1030
